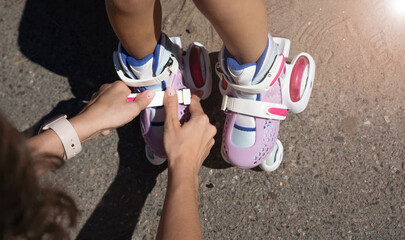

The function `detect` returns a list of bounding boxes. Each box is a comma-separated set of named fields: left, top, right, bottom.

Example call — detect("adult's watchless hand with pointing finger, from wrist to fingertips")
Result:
left=163, top=87, right=217, bottom=176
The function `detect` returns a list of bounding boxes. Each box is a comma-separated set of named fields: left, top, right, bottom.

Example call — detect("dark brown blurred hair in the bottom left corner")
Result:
left=0, top=113, right=78, bottom=239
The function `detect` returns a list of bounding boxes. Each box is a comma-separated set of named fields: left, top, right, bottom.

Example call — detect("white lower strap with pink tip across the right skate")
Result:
left=221, top=95, right=287, bottom=120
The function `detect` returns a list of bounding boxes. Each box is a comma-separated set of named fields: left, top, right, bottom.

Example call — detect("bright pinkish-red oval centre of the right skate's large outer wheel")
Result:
left=290, top=56, right=309, bottom=102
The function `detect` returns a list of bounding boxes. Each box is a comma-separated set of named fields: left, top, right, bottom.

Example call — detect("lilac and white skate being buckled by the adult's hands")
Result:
left=113, top=33, right=212, bottom=165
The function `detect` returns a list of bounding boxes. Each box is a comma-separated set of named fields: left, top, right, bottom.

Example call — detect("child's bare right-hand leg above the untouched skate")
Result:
left=194, top=0, right=268, bottom=64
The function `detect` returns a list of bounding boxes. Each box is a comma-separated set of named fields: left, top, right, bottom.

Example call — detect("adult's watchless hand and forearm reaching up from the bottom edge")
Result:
left=156, top=87, right=217, bottom=240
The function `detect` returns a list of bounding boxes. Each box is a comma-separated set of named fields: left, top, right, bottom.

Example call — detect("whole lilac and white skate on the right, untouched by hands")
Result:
left=215, top=35, right=315, bottom=171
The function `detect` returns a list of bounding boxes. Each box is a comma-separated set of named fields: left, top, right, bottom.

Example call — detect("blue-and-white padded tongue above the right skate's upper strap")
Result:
left=227, top=57, right=256, bottom=86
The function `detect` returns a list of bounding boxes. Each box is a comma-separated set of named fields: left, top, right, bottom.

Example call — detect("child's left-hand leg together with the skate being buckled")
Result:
left=105, top=0, right=211, bottom=165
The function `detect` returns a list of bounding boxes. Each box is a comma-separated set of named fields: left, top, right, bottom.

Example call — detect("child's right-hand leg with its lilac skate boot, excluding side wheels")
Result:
left=194, top=0, right=284, bottom=168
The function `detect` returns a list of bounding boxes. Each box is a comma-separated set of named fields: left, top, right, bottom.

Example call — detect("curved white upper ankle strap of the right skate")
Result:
left=216, top=54, right=285, bottom=93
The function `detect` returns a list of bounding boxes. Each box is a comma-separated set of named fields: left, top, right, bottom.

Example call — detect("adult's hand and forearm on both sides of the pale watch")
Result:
left=28, top=81, right=155, bottom=176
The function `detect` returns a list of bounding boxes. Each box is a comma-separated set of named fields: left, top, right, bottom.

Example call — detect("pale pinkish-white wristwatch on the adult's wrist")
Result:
left=41, top=114, right=82, bottom=160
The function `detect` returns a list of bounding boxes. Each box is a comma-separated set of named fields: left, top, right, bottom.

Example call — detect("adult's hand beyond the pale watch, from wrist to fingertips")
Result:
left=70, top=81, right=155, bottom=142
